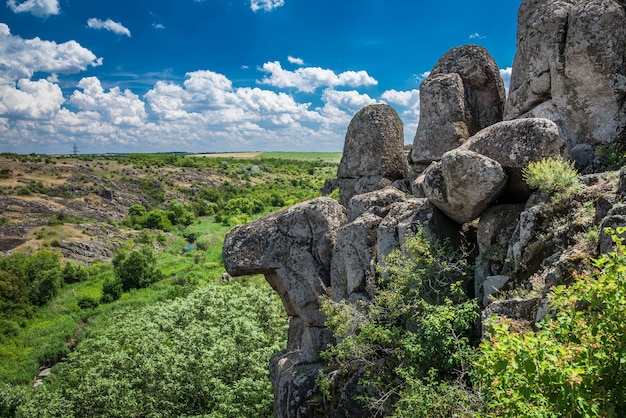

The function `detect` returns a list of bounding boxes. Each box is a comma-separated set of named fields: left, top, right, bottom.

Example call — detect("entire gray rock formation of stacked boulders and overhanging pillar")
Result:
left=224, top=0, right=626, bottom=417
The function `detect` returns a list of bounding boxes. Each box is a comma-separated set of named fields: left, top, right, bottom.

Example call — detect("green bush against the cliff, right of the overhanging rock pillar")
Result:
left=320, top=229, right=478, bottom=416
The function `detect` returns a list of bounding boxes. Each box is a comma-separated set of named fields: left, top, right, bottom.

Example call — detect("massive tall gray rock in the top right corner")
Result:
left=505, top=0, right=626, bottom=157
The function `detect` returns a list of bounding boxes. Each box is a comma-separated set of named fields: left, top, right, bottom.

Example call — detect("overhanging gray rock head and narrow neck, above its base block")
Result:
left=223, top=197, right=346, bottom=358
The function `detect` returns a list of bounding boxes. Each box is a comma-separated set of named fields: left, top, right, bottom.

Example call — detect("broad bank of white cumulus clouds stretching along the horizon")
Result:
left=0, top=23, right=426, bottom=153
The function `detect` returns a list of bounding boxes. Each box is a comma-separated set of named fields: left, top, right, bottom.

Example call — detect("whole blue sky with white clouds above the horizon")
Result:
left=0, top=0, right=521, bottom=154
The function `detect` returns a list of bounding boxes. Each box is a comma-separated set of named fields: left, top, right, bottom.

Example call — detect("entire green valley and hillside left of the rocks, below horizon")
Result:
left=0, top=153, right=338, bottom=416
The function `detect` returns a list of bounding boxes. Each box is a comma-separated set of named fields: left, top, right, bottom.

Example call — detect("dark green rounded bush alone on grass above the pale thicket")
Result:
left=113, top=245, right=161, bottom=291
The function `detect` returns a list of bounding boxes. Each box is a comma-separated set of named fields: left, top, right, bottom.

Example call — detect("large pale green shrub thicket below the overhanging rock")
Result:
left=14, top=283, right=286, bottom=418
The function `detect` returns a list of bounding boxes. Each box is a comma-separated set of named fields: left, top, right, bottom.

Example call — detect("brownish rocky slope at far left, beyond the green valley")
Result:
left=0, top=155, right=220, bottom=263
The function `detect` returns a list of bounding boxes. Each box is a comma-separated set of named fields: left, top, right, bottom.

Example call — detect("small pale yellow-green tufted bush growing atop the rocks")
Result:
left=522, top=158, right=580, bottom=194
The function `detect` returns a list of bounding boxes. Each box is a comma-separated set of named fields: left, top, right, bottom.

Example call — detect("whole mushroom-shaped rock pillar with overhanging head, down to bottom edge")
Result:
left=223, top=197, right=347, bottom=417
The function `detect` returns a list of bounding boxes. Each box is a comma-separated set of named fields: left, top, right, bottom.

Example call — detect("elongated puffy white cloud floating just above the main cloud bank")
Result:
left=260, top=61, right=378, bottom=93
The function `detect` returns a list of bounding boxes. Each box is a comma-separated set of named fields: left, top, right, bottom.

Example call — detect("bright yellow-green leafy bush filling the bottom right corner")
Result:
left=475, top=228, right=626, bottom=417
